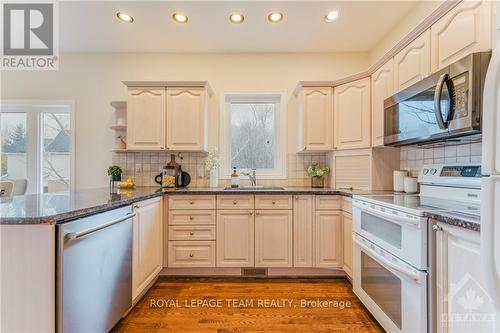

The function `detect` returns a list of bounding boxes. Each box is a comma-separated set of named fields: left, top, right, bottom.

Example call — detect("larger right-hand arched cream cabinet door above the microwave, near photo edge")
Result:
left=431, top=0, right=492, bottom=71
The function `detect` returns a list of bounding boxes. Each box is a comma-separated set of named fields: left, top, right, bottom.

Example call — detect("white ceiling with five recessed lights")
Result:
left=59, top=0, right=417, bottom=52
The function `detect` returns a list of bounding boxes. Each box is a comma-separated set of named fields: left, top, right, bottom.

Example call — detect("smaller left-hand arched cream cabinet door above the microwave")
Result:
left=394, top=30, right=431, bottom=92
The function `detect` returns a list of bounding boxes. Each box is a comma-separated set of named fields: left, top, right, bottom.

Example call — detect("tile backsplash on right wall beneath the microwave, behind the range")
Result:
left=400, top=142, right=482, bottom=176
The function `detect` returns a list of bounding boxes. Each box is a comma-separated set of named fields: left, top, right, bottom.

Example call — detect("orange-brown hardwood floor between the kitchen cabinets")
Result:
left=112, top=277, right=384, bottom=333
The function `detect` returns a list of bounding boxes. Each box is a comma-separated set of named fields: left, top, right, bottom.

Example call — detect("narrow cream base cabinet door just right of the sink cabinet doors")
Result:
left=293, top=195, right=314, bottom=267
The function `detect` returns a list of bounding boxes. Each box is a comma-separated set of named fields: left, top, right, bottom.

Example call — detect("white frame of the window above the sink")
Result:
left=219, top=91, right=287, bottom=179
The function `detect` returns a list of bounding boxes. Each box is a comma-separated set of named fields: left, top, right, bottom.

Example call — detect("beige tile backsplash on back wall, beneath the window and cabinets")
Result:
left=112, top=152, right=326, bottom=187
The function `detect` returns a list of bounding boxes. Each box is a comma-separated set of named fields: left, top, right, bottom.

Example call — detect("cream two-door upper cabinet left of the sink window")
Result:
left=124, top=81, right=212, bottom=151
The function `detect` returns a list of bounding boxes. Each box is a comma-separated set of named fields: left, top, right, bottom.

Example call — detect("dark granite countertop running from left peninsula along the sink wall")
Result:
left=0, top=187, right=374, bottom=224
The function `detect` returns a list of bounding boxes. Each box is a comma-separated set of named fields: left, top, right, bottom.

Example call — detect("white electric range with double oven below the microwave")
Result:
left=353, top=164, right=481, bottom=333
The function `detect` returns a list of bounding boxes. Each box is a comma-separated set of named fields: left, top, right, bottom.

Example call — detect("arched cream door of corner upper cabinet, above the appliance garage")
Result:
left=333, top=78, right=371, bottom=150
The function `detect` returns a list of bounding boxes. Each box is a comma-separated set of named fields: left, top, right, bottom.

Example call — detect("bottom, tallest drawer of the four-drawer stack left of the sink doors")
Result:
left=168, top=241, right=215, bottom=267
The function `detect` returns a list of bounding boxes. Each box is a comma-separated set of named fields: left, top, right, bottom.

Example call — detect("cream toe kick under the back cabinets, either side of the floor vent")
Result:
left=160, top=267, right=346, bottom=277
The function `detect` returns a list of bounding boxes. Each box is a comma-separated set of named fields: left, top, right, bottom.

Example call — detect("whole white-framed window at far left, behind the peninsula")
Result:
left=0, top=101, right=74, bottom=194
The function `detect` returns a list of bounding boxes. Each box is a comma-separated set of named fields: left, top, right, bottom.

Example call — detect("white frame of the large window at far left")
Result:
left=0, top=100, right=76, bottom=194
